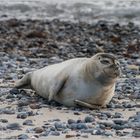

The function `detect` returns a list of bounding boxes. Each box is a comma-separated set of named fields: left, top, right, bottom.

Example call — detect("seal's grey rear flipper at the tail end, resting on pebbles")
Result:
left=14, top=73, right=31, bottom=89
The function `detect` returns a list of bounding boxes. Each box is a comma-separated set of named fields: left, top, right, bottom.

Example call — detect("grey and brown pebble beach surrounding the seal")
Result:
left=0, top=19, right=140, bottom=139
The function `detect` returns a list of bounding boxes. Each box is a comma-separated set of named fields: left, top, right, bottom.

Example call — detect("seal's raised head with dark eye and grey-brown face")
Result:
left=93, top=53, right=121, bottom=83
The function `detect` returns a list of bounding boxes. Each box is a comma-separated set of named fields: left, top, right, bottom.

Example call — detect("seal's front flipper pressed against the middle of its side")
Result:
left=49, top=73, right=68, bottom=101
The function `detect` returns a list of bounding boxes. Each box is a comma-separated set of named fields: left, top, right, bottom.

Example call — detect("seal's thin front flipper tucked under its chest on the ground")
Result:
left=74, top=100, right=101, bottom=109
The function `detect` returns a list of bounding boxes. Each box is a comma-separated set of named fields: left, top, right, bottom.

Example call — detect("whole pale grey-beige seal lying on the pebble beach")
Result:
left=15, top=53, right=121, bottom=108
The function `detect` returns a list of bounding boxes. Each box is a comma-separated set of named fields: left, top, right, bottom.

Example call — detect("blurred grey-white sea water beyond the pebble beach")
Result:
left=0, top=0, right=140, bottom=24
